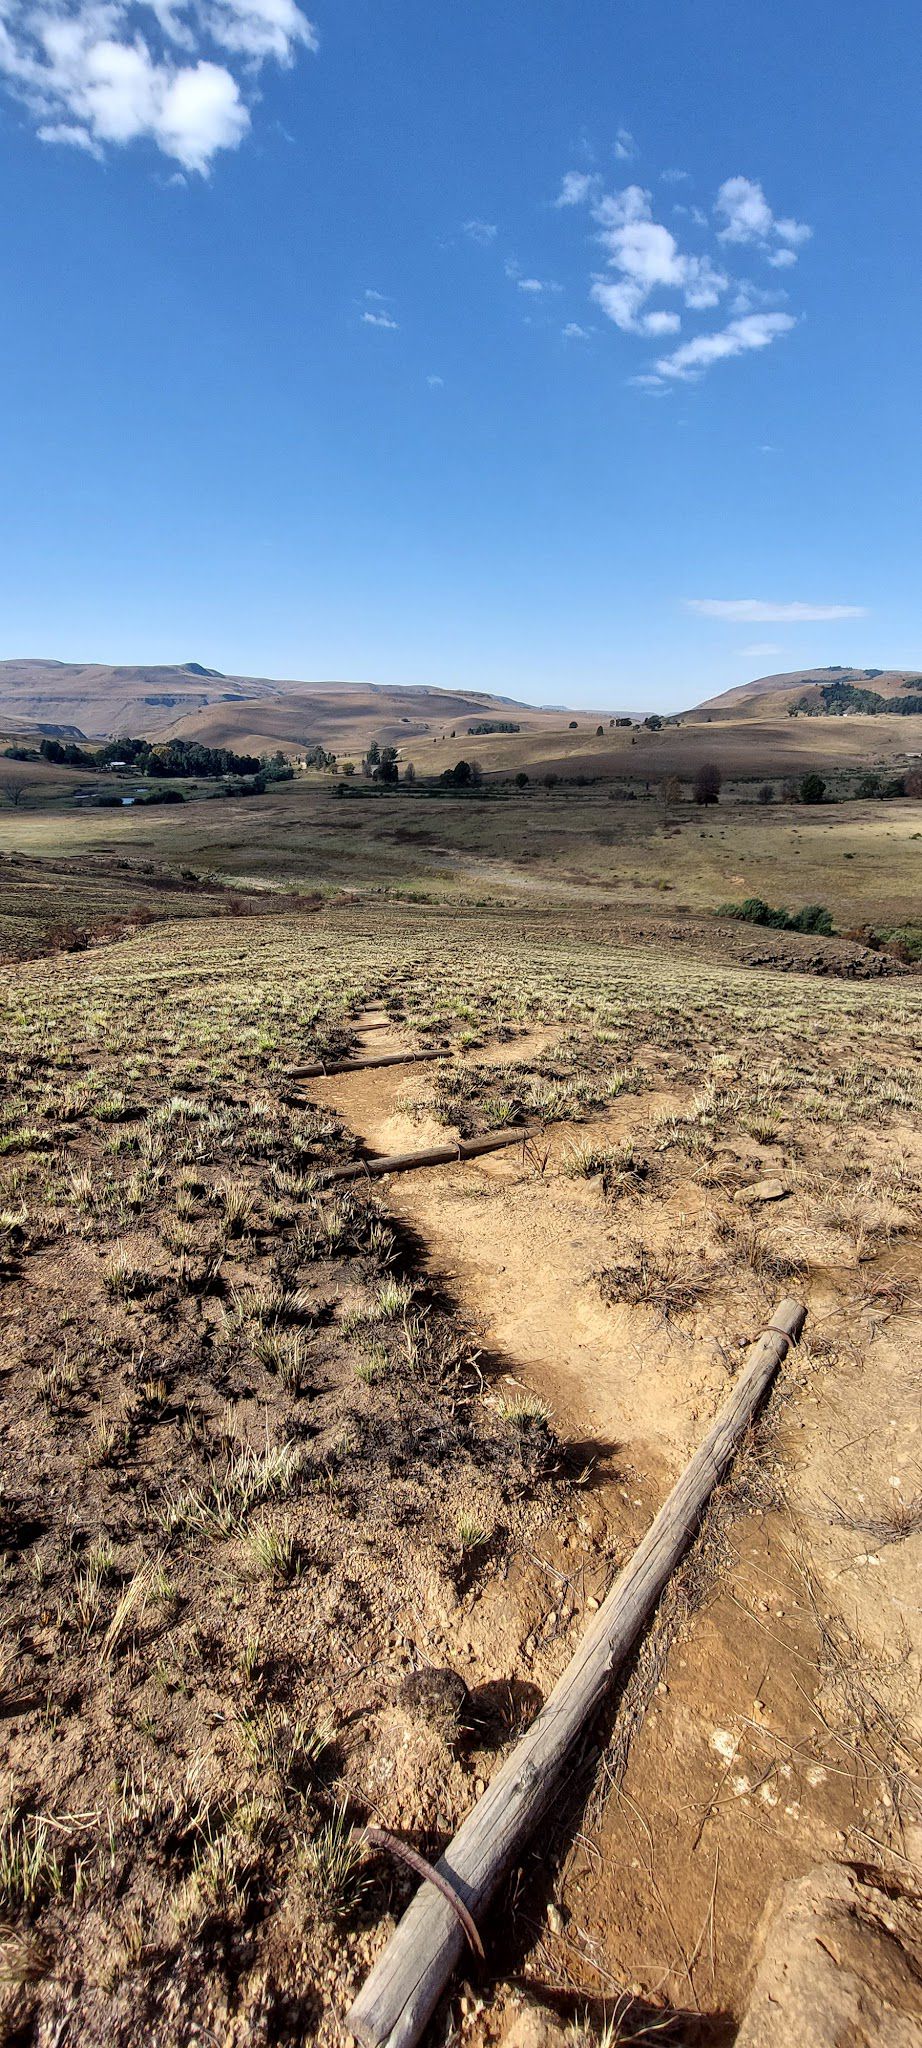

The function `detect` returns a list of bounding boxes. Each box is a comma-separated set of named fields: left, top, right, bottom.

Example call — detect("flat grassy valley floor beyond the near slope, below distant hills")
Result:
left=0, top=770, right=922, bottom=954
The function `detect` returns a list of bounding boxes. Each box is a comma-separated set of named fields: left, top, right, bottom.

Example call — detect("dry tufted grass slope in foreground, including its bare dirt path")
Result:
left=0, top=905, right=922, bottom=2048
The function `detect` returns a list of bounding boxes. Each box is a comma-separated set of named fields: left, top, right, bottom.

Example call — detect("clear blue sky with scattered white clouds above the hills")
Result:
left=0, top=0, right=922, bottom=709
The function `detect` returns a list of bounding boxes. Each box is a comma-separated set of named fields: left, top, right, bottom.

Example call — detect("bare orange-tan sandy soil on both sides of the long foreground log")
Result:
left=316, top=1015, right=922, bottom=2042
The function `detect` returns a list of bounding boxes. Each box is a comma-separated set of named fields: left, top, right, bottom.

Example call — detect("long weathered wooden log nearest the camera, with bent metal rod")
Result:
left=346, top=1300, right=807, bottom=2048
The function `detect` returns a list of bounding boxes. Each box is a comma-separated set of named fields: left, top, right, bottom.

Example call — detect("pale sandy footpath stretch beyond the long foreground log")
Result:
left=311, top=1026, right=725, bottom=1493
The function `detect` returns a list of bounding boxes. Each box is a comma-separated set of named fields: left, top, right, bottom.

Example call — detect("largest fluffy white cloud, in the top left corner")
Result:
left=0, top=0, right=318, bottom=174
